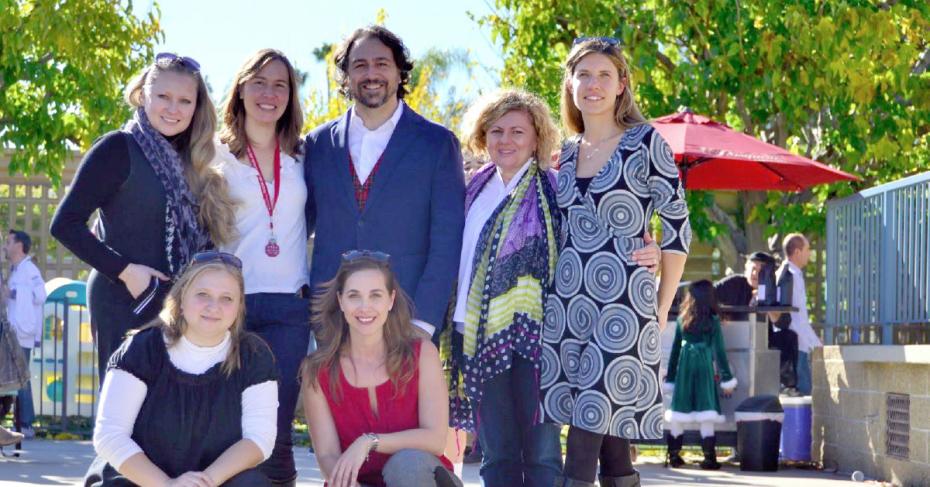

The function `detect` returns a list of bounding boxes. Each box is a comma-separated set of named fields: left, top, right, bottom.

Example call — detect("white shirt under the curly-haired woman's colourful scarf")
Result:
left=452, top=159, right=535, bottom=333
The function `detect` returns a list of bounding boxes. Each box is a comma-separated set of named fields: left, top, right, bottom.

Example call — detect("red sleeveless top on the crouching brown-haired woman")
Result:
left=317, top=340, right=452, bottom=486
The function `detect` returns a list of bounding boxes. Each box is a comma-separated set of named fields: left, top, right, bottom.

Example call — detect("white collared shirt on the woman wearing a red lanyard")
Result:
left=213, top=143, right=309, bottom=294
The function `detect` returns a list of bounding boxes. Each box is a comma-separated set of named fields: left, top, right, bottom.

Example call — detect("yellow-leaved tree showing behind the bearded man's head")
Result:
left=304, top=10, right=472, bottom=138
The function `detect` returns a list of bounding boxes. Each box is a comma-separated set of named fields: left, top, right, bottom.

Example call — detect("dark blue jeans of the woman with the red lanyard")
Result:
left=245, top=293, right=310, bottom=481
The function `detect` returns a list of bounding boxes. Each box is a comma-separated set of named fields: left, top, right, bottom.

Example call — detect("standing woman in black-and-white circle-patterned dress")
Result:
left=542, top=38, right=691, bottom=487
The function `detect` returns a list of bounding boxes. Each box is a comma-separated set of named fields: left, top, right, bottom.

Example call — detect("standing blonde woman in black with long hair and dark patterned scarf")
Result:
left=51, top=53, right=235, bottom=384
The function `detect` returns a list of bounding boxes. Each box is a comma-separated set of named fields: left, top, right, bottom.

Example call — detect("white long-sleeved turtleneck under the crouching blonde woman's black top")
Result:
left=94, top=332, right=278, bottom=470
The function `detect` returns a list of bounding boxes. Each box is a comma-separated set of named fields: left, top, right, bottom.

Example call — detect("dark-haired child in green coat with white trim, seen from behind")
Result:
left=665, top=279, right=736, bottom=470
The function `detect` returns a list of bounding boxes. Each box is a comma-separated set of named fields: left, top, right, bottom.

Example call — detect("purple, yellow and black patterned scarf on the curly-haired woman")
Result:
left=450, top=161, right=560, bottom=430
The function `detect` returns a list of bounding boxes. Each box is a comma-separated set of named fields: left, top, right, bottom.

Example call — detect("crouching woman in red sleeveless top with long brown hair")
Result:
left=302, top=251, right=462, bottom=487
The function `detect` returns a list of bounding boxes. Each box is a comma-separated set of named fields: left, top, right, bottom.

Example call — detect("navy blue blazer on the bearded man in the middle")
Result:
left=304, top=106, right=465, bottom=334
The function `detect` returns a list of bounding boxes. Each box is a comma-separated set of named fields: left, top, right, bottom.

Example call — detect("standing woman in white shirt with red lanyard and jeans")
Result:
left=214, top=49, right=310, bottom=485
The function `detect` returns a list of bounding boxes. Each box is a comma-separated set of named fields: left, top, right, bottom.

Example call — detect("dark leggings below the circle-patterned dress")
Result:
left=564, top=426, right=636, bottom=482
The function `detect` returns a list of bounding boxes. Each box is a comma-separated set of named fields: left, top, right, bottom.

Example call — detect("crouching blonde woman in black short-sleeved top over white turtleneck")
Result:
left=84, top=251, right=278, bottom=487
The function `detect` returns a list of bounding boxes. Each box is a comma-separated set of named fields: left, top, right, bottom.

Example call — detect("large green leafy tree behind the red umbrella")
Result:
left=479, top=0, right=930, bottom=269
